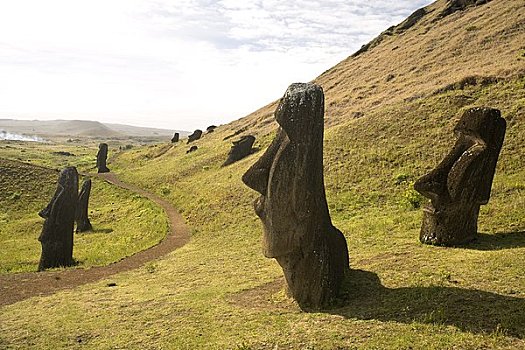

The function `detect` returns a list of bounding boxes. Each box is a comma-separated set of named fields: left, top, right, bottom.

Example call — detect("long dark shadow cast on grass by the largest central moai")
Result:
left=327, top=270, right=525, bottom=339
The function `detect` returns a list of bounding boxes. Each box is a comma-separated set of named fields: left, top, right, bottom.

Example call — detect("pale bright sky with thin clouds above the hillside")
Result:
left=0, top=0, right=432, bottom=130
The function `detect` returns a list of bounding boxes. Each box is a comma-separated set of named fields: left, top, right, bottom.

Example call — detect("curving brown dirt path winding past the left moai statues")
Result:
left=0, top=173, right=190, bottom=306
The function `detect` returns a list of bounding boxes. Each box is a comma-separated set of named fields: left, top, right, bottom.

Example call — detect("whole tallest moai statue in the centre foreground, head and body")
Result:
left=242, top=84, right=349, bottom=309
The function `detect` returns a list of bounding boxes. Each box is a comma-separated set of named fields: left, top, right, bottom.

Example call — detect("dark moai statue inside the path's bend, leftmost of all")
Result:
left=38, top=167, right=78, bottom=271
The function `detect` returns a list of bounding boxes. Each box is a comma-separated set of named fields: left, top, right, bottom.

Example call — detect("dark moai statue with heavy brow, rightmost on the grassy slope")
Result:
left=414, top=108, right=506, bottom=246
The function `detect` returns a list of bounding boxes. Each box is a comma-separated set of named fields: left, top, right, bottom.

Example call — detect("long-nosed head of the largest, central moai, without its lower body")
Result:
left=242, top=84, right=328, bottom=258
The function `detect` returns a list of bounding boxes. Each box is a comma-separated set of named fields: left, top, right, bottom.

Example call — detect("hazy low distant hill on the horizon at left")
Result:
left=0, top=119, right=189, bottom=138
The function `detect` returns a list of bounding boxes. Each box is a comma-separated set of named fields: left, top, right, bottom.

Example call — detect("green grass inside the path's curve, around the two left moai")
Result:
left=0, top=158, right=167, bottom=273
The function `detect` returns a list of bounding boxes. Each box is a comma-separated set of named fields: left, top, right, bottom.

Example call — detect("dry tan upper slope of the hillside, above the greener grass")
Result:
left=230, top=0, right=525, bottom=135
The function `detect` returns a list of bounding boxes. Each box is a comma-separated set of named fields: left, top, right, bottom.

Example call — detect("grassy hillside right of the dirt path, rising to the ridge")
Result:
left=0, top=0, right=525, bottom=349
